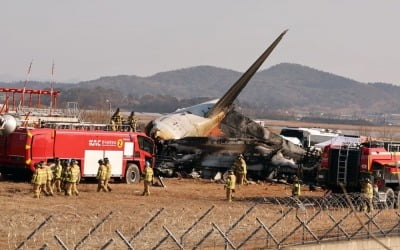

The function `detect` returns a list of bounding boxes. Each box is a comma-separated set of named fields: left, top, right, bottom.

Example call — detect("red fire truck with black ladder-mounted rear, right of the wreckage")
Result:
left=318, top=141, right=400, bottom=206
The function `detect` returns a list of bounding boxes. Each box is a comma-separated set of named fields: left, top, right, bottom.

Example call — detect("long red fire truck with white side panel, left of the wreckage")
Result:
left=0, top=126, right=155, bottom=183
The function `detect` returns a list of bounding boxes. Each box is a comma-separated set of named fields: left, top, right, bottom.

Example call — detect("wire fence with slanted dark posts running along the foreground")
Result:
left=2, top=195, right=400, bottom=249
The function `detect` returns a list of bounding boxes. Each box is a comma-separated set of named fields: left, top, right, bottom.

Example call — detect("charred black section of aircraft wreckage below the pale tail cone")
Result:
left=156, top=109, right=319, bottom=179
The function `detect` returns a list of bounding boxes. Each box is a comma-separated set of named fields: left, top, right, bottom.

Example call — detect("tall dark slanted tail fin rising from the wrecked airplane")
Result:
left=205, top=30, right=288, bottom=117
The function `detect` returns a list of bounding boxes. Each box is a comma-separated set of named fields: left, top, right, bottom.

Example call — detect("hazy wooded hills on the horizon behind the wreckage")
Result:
left=2, top=63, right=400, bottom=116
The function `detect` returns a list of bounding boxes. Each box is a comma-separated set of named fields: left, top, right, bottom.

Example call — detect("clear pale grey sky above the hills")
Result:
left=0, top=0, right=400, bottom=84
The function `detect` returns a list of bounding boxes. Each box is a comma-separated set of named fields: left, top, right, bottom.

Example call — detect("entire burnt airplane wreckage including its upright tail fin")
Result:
left=145, top=30, right=319, bottom=182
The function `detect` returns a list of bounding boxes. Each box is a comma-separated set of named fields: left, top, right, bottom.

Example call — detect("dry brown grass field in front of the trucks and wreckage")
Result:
left=0, top=179, right=399, bottom=249
